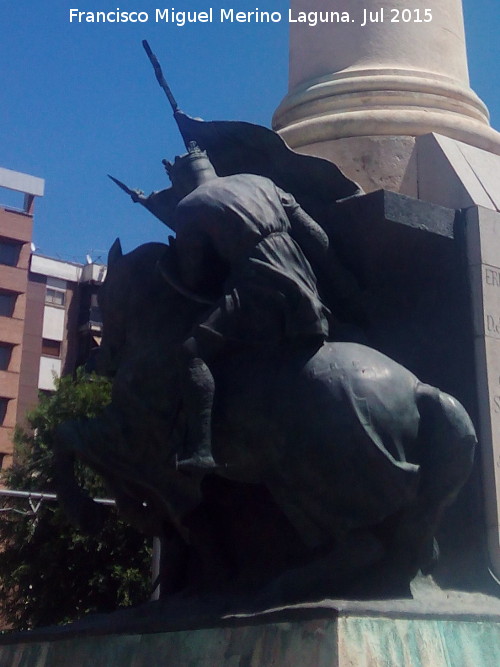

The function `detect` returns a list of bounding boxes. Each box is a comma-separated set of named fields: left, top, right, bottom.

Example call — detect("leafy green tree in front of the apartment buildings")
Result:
left=0, top=371, right=151, bottom=629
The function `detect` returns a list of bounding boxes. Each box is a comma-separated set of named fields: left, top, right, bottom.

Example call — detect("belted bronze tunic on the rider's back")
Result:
left=175, top=174, right=328, bottom=343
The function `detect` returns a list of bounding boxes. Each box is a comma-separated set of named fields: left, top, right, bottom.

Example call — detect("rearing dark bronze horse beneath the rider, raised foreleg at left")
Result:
left=56, top=243, right=476, bottom=602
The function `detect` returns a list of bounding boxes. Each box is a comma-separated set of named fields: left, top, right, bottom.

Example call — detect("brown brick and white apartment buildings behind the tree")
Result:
left=0, top=169, right=106, bottom=467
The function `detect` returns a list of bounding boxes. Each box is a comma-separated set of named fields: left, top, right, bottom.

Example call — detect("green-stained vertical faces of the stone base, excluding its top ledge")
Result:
left=0, top=614, right=500, bottom=667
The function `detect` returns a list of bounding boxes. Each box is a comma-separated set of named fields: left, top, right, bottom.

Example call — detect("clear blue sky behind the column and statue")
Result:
left=0, top=0, right=500, bottom=261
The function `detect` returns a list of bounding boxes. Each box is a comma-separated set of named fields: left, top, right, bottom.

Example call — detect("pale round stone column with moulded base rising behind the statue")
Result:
left=273, top=0, right=500, bottom=194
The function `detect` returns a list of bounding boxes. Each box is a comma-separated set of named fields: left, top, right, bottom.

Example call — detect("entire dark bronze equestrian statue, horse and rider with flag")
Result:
left=57, top=47, right=476, bottom=606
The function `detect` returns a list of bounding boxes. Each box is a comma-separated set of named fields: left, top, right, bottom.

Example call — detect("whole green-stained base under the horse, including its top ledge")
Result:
left=0, top=580, right=500, bottom=667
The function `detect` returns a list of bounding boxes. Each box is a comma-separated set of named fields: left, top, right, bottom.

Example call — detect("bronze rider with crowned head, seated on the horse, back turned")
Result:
left=150, top=142, right=329, bottom=472
